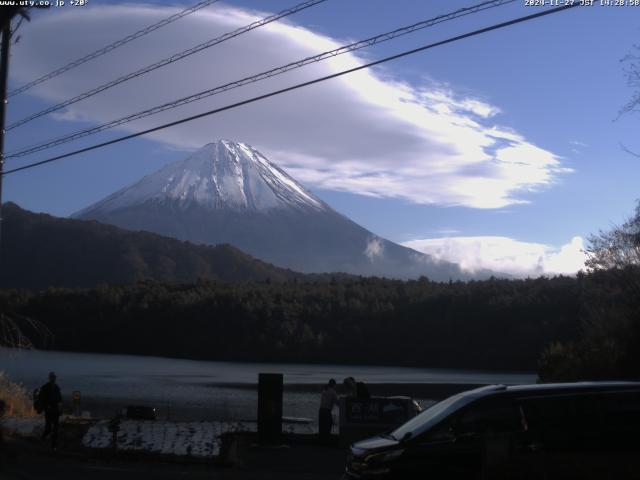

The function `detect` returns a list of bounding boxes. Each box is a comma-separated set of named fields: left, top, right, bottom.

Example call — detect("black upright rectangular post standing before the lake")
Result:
left=258, top=373, right=282, bottom=444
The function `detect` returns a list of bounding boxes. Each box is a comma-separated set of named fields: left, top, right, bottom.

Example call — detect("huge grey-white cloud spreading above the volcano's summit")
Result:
left=11, top=4, right=569, bottom=208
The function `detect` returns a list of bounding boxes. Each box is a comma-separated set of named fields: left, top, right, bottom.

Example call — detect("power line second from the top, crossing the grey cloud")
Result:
left=6, top=0, right=327, bottom=131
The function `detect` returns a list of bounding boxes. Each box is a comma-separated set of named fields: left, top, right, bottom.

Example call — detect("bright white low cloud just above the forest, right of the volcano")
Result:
left=403, top=236, right=586, bottom=277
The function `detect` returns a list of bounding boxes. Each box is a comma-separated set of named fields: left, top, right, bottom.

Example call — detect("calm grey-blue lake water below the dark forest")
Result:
left=0, top=350, right=536, bottom=420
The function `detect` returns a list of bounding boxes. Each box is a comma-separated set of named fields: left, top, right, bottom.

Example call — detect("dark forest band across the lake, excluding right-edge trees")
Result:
left=0, top=276, right=586, bottom=370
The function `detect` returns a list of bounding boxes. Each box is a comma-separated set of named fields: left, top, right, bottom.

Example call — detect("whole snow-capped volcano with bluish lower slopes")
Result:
left=73, top=140, right=469, bottom=280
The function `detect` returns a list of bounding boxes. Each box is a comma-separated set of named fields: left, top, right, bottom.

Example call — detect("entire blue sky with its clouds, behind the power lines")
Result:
left=4, top=0, right=640, bottom=274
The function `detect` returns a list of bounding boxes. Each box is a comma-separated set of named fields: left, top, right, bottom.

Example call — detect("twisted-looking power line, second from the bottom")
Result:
left=5, top=0, right=515, bottom=159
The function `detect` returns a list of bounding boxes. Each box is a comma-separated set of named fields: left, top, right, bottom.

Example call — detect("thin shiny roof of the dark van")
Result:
left=461, top=381, right=640, bottom=399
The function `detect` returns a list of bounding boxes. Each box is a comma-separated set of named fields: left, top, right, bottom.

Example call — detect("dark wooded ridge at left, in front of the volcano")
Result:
left=0, top=203, right=302, bottom=288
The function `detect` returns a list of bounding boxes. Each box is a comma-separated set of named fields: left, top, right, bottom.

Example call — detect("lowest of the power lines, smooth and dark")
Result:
left=2, top=2, right=580, bottom=176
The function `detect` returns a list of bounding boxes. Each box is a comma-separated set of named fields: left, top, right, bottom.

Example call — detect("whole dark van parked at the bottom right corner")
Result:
left=346, top=382, right=640, bottom=480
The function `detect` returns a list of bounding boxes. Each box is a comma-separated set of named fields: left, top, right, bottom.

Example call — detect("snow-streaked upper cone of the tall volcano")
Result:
left=79, top=140, right=326, bottom=216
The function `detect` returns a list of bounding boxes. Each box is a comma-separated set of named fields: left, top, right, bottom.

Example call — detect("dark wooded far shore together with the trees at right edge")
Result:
left=0, top=199, right=640, bottom=381
